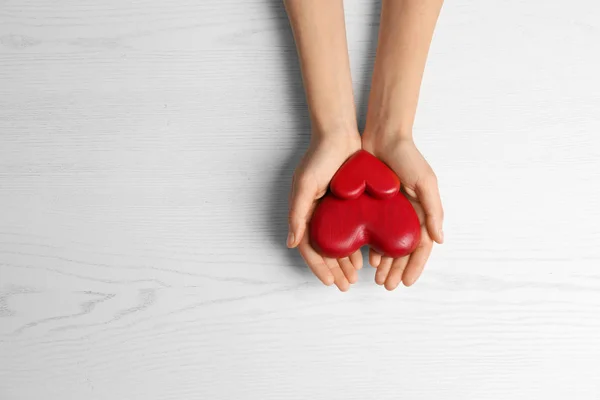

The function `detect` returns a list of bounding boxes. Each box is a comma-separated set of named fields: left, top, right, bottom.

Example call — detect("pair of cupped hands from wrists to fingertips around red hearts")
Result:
left=287, top=132, right=444, bottom=292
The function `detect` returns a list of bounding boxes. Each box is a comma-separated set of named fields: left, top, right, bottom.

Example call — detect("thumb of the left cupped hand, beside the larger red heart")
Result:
left=287, top=177, right=317, bottom=248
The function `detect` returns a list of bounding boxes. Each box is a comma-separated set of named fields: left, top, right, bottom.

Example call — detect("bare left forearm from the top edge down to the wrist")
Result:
left=285, top=0, right=357, bottom=134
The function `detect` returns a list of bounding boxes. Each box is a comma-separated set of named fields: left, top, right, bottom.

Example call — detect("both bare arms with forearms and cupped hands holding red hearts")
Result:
left=285, top=0, right=444, bottom=291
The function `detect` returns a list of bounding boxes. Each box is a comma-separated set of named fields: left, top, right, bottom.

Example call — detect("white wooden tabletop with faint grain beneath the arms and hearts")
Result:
left=0, top=0, right=600, bottom=400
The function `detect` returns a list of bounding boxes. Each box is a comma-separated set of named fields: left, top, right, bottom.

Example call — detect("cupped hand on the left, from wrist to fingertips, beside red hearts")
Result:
left=287, top=132, right=362, bottom=292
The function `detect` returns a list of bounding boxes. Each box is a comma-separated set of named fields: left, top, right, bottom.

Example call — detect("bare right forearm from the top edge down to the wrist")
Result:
left=365, top=0, right=443, bottom=138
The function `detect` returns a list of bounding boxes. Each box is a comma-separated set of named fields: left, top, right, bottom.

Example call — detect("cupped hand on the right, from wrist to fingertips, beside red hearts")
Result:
left=363, top=133, right=444, bottom=290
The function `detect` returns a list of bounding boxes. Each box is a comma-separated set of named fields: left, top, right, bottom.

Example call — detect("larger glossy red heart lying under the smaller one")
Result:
left=310, top=193, right=421, bottom=258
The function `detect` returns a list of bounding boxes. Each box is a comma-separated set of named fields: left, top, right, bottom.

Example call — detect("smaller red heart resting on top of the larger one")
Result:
left=329, top=150, right=400, bottom=199
